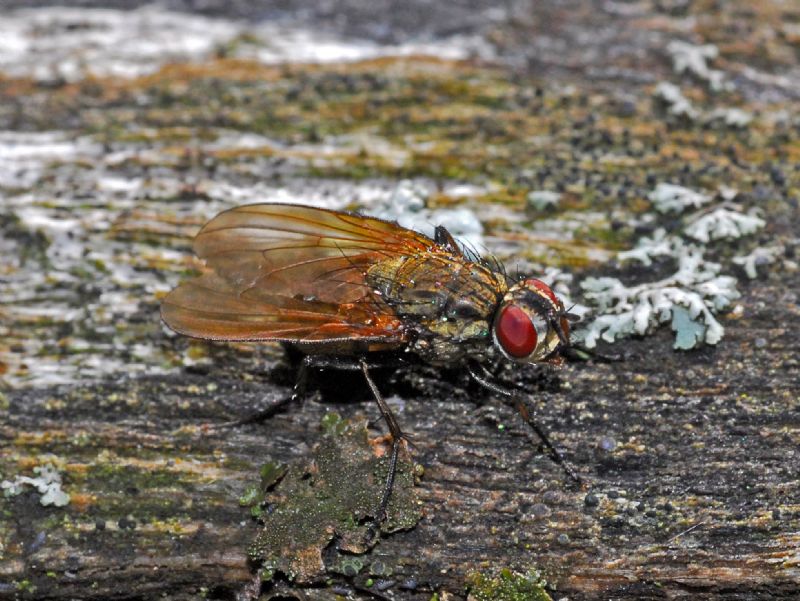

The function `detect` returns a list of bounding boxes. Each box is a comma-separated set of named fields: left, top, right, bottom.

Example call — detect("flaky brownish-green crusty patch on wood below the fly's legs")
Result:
left=243, top=414, right=421, bottom=583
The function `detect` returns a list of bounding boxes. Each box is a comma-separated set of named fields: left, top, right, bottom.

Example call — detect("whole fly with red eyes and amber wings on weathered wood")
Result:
left=161, top=203, right=578, bottom=522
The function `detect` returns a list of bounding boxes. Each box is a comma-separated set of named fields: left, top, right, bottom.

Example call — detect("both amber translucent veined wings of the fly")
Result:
left=161, top=204, right=434, bottom=343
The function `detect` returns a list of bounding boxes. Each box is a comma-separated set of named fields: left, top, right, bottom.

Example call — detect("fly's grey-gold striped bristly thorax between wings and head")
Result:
left=367, top=252, right=506, bottom=363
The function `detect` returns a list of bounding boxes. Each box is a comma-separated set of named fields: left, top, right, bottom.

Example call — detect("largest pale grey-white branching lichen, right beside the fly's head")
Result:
left=580, top=246, right=740, bottom=349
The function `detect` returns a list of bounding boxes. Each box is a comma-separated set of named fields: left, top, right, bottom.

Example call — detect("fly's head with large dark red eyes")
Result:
left=492, top=279, right=571, bottom=363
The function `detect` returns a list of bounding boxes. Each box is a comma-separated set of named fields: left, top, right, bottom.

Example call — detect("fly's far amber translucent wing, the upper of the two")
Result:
left=194, top=204, right=433, bottom=304
